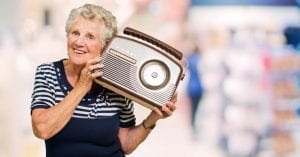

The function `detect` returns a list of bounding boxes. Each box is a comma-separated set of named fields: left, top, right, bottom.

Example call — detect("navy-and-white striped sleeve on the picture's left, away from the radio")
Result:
left=31, top=65, right=55, bottom=112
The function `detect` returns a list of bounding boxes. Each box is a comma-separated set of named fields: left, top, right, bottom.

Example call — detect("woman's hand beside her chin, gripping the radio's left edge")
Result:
left=77, top=56, right=103, bottom=91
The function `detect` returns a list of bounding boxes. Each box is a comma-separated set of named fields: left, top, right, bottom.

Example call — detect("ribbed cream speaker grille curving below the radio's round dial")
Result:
left=102, top=53, right=176, bottom=104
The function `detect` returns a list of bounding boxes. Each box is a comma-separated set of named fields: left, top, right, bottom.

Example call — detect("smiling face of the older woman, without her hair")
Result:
left=67, top=17, right=103, bottom=65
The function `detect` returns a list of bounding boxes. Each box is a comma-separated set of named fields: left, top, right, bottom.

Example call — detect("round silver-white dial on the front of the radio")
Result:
left=140, top=60, right=170, bottom=90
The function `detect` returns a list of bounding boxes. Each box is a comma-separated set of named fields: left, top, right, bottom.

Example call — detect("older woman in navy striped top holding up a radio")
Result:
left=31, top=4, right=176, bottom=157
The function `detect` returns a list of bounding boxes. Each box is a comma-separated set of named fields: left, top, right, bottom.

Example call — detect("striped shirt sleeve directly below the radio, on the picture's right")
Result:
left=120, top=98, right=136, bottom=128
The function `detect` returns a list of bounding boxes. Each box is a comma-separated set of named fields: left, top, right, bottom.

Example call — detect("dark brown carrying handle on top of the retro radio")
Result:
left=123, top=27, right=182, bottom=60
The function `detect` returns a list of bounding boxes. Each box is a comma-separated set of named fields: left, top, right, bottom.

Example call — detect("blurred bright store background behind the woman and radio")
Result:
left=0, top=0, right=300, bottom=157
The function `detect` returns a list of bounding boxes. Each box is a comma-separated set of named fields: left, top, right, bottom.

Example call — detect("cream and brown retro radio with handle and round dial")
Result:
left=95, top=27, right=184, bottom=109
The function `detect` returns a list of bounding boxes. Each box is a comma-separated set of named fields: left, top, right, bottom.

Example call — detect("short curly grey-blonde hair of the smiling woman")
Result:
left=65, top=4, right=117, bottom=47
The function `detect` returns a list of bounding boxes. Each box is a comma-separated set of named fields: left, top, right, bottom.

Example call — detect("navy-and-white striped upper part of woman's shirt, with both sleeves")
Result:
left=31, top=60, right=135, bottom=127
